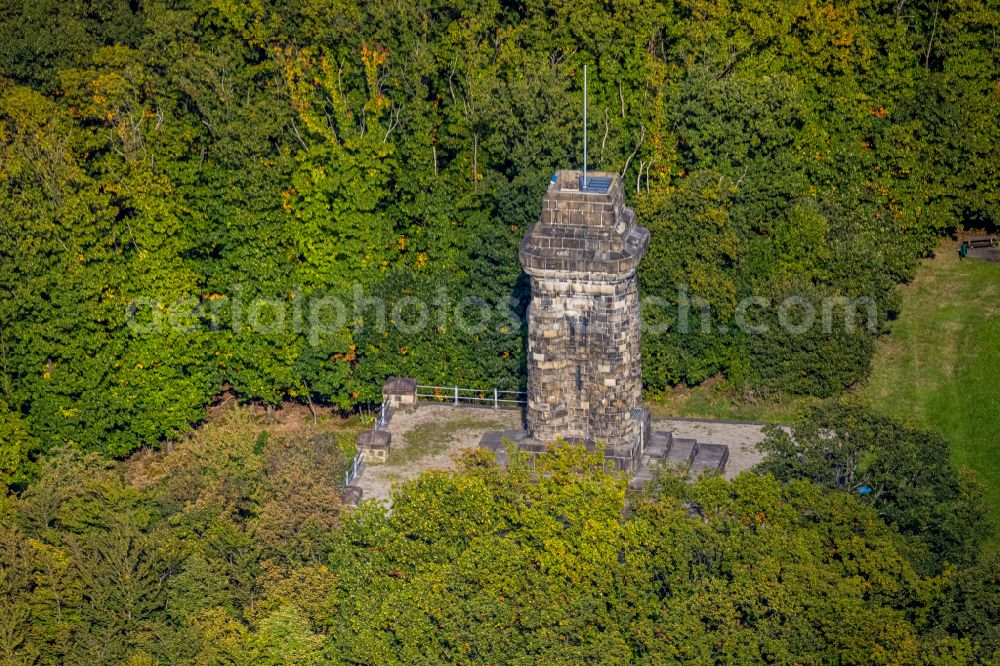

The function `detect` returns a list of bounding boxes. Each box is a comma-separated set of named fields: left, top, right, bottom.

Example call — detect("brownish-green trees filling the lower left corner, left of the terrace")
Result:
left=0, top=411, right=356, bottom=664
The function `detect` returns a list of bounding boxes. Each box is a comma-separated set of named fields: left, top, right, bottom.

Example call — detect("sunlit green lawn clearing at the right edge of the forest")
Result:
left=862, top=243, right=1000, bottom=549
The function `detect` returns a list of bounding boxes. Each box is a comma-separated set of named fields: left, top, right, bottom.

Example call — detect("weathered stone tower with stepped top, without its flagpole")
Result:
left=519, top=171, right=649, bottom=472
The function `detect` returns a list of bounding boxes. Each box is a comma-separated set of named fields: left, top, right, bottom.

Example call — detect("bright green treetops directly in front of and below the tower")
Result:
left=316, top=448, right=996, bottom=663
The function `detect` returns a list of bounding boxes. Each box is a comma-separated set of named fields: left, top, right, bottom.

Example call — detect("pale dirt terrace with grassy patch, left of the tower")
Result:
left=354, top=405, right=521, bottom=501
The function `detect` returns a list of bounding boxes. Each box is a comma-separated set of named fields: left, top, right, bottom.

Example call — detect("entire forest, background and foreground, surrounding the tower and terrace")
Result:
left=0, top=0, right=1000, bottom=666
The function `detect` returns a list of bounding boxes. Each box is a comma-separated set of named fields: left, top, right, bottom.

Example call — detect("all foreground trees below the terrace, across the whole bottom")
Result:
left=0, top=418, right=1000, bottom=664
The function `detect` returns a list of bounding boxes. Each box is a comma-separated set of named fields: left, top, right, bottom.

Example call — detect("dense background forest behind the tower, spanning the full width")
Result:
left=0, top=0, right=1000, bottom=472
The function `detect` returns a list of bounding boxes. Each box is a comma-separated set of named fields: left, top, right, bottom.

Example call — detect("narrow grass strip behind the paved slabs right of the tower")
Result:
left=646, top=382, right=817, bottom=423
